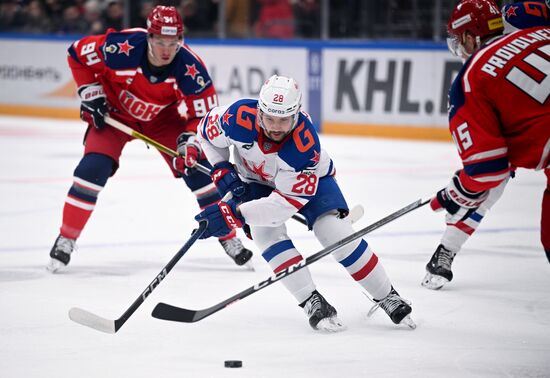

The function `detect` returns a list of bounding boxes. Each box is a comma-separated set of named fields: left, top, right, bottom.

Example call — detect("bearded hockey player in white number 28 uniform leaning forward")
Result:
left=188, top=75, right=415, bottom=331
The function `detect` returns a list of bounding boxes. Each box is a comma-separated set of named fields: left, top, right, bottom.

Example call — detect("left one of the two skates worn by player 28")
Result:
left=300, top=290, right=346, bottom=332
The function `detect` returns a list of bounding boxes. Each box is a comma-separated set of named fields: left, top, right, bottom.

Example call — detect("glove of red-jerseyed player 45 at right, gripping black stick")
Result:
left=430, top=171, right=489, bottom=224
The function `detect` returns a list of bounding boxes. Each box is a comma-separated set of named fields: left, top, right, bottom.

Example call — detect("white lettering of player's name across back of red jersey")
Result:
left=481, top=28, right=550, bottom=77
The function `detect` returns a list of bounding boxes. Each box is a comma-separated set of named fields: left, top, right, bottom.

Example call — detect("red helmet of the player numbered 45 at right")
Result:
left=447, top=0, right=504, bottom=56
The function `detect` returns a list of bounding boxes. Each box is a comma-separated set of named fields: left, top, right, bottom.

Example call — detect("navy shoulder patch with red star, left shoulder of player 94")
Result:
left=103, top=31, right=147, bottom=70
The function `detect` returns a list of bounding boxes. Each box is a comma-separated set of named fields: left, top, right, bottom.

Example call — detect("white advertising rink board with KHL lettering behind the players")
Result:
left=0, top=33, right=461, bottom=140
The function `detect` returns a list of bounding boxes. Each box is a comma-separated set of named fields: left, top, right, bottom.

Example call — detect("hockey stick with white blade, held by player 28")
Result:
left=69, top=221, right=208, bottom=333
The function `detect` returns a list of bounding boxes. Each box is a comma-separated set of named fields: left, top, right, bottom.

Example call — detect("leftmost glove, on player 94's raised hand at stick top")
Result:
left=78, top=83, right=107, bottom=129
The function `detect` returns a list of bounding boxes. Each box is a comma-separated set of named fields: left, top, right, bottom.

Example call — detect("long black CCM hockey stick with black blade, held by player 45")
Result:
left=152, top=199, right=430, bottom=323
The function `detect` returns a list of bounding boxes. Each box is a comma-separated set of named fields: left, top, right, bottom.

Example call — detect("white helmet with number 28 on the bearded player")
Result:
left=258, top=75, right=302, bottom=130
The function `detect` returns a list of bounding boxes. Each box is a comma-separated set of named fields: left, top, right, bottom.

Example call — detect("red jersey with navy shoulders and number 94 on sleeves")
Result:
left=68, top=29, right=217, bottom=131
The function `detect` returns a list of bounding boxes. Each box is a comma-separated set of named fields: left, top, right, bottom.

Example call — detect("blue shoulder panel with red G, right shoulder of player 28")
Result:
left=279, top=113, right=321, bottom=172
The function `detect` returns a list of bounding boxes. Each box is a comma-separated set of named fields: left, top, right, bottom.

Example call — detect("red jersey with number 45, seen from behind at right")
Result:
left=449, top=27, right=550, bottom=192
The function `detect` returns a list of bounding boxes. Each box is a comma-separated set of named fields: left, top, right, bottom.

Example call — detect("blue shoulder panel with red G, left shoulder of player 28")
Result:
left=220, top=99, right=258, bottom=143
